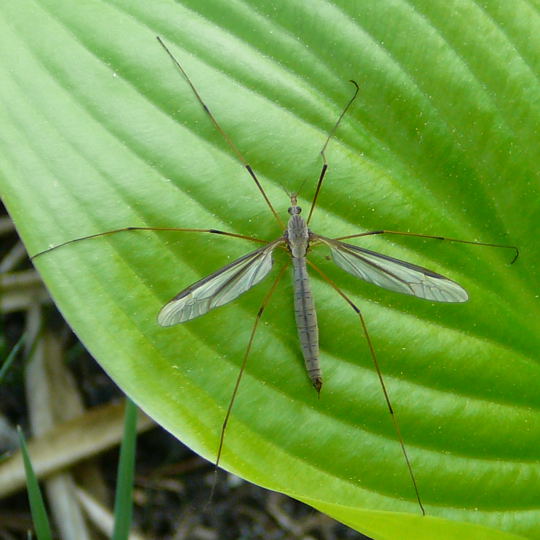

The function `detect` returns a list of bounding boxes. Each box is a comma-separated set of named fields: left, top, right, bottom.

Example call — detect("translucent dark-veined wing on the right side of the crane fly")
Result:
left=318, top=236, right=469, bottom=302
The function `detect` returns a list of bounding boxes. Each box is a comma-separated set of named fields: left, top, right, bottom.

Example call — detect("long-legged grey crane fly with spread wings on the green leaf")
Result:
left=32, top=37, right=519, bottom=515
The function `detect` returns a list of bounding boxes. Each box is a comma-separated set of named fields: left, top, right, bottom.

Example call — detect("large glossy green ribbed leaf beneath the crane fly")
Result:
left=0, top=0, right=540, bottom=538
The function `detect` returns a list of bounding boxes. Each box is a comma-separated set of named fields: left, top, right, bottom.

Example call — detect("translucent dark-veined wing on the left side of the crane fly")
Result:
left=158, top=239, right=283, bottom=326
